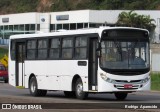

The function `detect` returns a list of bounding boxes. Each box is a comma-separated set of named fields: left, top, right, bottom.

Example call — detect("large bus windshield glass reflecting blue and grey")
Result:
left=100, top=40, right=149, bottom=70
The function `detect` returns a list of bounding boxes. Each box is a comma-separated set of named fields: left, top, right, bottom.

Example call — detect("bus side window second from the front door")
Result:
left=62, top=38, right=73, bottom=59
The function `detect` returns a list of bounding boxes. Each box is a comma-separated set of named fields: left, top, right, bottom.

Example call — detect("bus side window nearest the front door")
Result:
left=75, top=37, right=87, bottom=59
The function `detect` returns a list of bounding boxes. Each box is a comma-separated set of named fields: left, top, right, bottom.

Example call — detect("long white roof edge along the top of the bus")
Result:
left=10, top=26, right=147, bottom=39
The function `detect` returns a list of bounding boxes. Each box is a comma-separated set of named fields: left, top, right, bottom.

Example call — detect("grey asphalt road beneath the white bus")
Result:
left=0, top=82, right=160, bottom=112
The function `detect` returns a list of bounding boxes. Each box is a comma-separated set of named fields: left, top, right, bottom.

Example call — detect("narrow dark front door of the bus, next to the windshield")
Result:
left=88, top=38, right=98, bottom=91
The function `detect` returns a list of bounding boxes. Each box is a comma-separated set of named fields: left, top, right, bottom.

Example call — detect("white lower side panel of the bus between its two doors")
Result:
left=25, top=60, right=88, bottom=91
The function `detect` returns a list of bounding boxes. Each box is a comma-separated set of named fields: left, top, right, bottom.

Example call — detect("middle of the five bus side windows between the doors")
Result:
left=49, top=38, right=60, bottom=59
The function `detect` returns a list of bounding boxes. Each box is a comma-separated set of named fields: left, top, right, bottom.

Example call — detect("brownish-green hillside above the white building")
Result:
left=0, top=0, right=160, bottom=14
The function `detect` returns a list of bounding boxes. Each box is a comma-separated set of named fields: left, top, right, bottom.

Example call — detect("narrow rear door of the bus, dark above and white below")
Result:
left=15, top=42, right=25, bottom=86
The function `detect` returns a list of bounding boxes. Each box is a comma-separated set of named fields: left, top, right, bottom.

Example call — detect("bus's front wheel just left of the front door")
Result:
left=75, top=78, right=88, bottom=99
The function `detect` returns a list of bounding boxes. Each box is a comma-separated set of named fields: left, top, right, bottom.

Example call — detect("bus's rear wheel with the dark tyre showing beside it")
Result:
left=29, top=77, right=47, bottom=96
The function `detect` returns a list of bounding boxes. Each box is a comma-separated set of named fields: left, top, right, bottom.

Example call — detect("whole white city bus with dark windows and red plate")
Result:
left=9, top=27, right=150, bottom=100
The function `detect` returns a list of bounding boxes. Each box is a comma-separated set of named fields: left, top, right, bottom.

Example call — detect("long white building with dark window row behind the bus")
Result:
left=0, top=10, right=160, bottom=43
